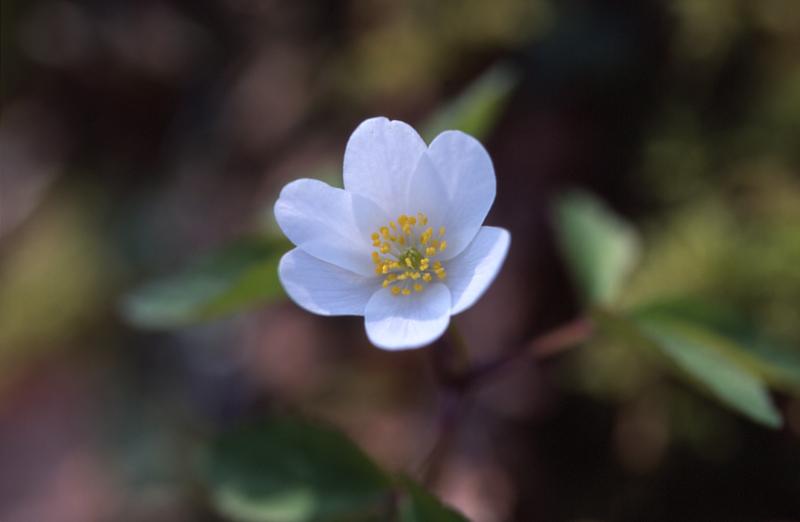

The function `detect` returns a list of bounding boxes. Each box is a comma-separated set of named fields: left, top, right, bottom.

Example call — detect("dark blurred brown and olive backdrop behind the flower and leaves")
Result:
left=0, top=0, right=800, bottom=522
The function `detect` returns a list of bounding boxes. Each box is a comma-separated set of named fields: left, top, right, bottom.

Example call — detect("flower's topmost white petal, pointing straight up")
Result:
left=344, top=117, right=426, bottom=219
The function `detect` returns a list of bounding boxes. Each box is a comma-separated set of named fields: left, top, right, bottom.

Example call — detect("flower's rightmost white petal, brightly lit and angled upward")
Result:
left=445, top=227, right=511, bottom=315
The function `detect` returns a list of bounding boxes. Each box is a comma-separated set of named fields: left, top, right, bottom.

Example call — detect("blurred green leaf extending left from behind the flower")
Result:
left=122, top=237, right=291, bottom=329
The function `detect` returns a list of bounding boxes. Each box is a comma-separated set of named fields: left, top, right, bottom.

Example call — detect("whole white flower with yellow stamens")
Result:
left=275, top=118, right=510, bottom=350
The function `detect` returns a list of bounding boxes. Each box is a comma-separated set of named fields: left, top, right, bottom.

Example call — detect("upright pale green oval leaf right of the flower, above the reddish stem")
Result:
left=555, top=192, right=639, bottom=304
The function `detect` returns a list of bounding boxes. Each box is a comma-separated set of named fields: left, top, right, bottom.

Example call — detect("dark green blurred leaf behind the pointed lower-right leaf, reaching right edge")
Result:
left=635, top=299, right=800, bottom=394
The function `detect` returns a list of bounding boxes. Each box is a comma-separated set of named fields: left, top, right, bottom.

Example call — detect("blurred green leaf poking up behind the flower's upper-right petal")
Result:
left=421, top=64, right=519, bottom=142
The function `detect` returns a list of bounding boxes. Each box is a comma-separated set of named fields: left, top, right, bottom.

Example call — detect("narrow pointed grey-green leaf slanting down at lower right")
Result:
left=635, top=315, right=782, bottom=428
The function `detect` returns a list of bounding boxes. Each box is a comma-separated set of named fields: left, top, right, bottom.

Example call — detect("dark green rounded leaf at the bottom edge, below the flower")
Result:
left=205, top=418, right=392, bottom=522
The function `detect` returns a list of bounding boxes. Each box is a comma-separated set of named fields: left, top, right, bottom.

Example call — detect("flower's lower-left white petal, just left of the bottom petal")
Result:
left=278, top=248, right=380, bottom=315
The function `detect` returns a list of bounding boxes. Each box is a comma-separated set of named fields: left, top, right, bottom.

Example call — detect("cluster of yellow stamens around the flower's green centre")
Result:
left=372, top=212, right=447, bottom=296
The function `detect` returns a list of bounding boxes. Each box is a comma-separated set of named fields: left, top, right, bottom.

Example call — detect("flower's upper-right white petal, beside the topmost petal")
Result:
left=427, top=131, right=496, bottom=259
